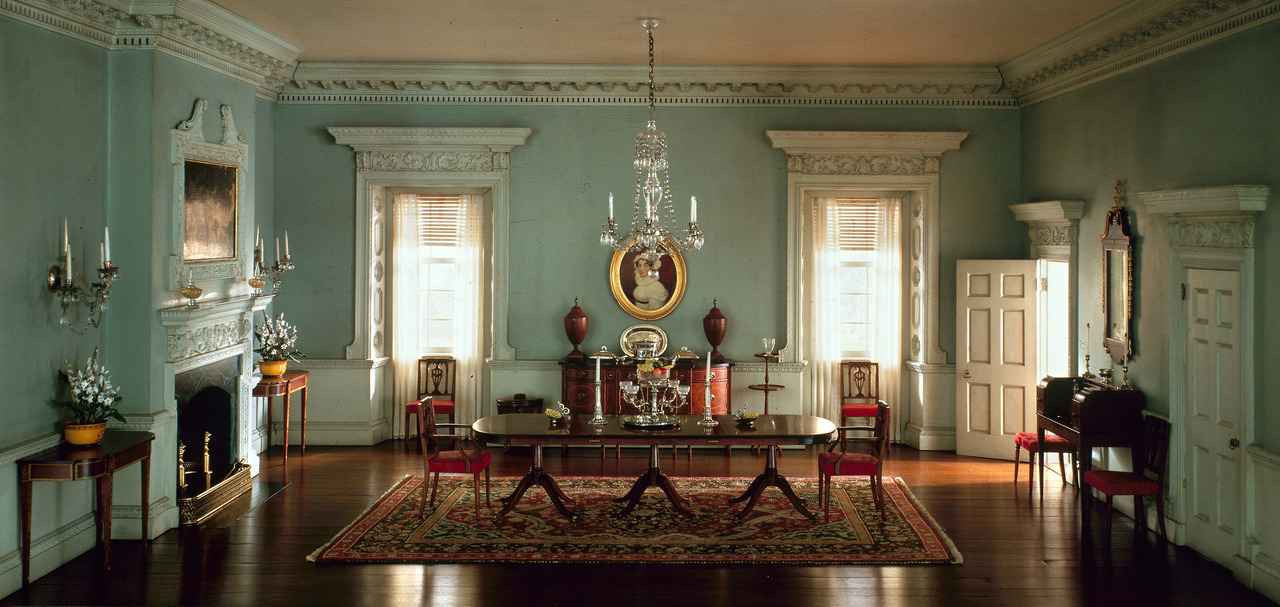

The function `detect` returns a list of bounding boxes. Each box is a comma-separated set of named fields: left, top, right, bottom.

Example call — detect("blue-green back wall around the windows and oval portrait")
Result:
left=275, top=105, right=1025, bottom=360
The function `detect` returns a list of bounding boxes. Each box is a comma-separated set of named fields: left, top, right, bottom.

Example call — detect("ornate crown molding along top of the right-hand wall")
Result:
left=1000, top=0, right=1280, bottom=106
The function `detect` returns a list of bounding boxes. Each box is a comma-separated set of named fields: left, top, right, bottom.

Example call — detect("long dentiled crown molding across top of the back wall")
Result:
left=282, top=63, right=1016, bottom=108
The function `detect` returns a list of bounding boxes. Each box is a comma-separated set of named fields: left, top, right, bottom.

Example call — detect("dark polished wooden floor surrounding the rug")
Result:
left=0, top=441, right=1275, bottom=607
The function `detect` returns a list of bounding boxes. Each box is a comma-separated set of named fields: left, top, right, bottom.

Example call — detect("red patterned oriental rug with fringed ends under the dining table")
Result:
left=307, top=476, right=963, bottom=565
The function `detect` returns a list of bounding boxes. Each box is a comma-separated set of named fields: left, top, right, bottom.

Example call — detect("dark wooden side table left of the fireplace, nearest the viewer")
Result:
left=18, top=430, right=156, bottom=587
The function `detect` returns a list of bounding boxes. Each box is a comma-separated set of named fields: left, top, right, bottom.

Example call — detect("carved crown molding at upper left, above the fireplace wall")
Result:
left=0, top=0, right=302, bottom=100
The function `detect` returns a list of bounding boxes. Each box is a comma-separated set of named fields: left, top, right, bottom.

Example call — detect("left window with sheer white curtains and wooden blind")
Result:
left=389, top=193, right=484, bottom=435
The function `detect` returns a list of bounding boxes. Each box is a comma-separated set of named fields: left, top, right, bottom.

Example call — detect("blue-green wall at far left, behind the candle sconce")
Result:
left=0, top=19, right=108, bottom=445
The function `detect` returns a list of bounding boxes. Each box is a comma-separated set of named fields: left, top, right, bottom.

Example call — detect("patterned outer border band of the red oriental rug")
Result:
left=306, top=474, right=964, bottom=566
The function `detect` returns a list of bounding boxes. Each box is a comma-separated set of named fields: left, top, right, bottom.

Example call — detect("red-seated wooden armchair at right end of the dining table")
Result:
left=818, top=403, right=888, bottom=521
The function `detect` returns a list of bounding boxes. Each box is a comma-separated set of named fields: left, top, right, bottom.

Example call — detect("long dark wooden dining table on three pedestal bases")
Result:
left=471, top=414, right=836, bottom=521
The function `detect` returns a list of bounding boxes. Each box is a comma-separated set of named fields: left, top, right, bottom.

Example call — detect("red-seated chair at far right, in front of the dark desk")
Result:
left=1083, top=415, right=1169, bottom=542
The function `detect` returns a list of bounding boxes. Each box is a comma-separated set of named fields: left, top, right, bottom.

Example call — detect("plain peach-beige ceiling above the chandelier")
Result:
left=207, top=0, right=1140, bottom=67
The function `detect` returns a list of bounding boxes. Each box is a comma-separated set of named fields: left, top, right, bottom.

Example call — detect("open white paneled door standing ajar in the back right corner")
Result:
left=956, top=260, right=1039, bottom=460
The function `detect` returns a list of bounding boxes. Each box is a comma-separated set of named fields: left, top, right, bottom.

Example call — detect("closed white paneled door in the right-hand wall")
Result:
left=1185, top=269, right=1243, bottom=566
